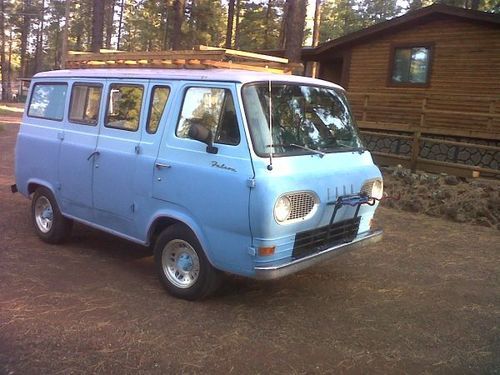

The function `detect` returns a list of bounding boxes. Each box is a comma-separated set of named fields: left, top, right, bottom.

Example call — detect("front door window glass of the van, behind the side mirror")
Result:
left=176, top=87, right=240, bottom=145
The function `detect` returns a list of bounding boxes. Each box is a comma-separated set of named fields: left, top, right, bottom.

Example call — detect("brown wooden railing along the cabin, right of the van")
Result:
left=348, top=92, right=500, bottom=177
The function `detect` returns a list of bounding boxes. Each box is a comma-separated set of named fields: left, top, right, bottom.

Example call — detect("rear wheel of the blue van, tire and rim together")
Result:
left=31, top=187, right=73, bottom=244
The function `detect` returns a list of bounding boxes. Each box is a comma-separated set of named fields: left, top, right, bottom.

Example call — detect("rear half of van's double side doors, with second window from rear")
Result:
left=59, top=80, right=104, bottom=220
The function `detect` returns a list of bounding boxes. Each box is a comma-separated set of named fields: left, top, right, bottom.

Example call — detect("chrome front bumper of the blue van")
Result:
left=254, top=230, right=382, bottom=280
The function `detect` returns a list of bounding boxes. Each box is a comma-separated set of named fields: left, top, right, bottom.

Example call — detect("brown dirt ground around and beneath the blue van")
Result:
left=0, top=120, right=500, bottom=375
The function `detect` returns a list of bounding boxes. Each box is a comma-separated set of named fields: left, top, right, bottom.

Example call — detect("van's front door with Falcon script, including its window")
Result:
left=153, top=82, right=253, bottom=271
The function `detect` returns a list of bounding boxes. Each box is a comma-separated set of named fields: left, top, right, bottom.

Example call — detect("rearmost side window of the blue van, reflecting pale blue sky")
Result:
left=28, top=83, right=68, bottom=121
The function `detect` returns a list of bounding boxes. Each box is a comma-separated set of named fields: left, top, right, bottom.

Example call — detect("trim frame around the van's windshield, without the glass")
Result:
left=239, top=80, right=366, bottom=159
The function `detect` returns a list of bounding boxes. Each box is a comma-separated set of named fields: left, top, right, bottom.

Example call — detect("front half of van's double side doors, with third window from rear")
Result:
left=93, top=80, right=147, bottom=234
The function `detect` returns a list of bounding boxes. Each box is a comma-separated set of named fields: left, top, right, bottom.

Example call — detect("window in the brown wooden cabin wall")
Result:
left=390, top=46, right=431, bottom=86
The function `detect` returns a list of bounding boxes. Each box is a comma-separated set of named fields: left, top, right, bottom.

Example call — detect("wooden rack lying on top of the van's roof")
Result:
left=66, top=46, right=302, bottom=74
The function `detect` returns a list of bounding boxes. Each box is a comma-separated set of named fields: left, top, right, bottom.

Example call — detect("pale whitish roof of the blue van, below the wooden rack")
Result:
left=33, top=68, right=346, bottom=88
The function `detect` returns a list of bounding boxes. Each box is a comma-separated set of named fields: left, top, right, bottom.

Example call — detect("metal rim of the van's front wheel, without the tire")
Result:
left=161, top=240, right=200, bottom=289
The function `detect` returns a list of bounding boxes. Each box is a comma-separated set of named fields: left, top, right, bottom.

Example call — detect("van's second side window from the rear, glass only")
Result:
left=69, top=83, right=102, bottom=125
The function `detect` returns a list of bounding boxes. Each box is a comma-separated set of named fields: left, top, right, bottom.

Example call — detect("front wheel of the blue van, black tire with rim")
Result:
left=154, top=224, right=222, bottom=301
